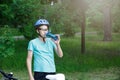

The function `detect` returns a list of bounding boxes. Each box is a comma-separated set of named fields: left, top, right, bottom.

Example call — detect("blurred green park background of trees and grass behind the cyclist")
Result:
left=0, top=0, right=120, bottom=80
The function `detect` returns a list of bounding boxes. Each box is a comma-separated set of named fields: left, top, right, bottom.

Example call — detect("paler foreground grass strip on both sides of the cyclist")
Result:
left=1, top=67, right=120, bottom=80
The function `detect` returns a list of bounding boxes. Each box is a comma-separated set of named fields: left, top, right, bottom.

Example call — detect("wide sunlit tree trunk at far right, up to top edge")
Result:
left=100, top=0, right=112, bottom=41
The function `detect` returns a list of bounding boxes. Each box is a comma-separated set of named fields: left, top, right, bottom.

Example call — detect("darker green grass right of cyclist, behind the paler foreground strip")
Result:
left=57, top=39, right=120, bottom=72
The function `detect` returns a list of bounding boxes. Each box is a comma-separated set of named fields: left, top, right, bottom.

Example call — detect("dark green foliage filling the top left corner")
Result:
left=0, top=0, right=40, bottom=28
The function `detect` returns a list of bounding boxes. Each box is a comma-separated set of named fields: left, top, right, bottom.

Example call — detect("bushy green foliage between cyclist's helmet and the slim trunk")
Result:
left=45, top=4, right=80, bottom=37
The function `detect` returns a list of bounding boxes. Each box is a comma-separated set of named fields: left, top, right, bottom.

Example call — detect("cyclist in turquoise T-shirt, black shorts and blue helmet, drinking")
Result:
left=26, top=19, right=63, bottom=80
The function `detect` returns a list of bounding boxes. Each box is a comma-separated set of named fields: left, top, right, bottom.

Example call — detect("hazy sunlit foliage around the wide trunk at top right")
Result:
left=86, top=0, right=120, bottom=33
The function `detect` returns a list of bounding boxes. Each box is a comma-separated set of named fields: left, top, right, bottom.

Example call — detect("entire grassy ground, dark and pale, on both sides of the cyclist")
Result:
left=2, top=32, right=120, bottom=80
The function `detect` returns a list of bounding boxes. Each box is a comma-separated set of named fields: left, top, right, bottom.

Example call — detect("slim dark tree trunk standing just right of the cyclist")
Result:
left=72, top=0, right=88, bottom=53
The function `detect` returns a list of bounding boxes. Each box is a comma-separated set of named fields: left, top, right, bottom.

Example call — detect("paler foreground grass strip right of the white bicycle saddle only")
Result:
left=66, top=68, right=120, bottom=80
